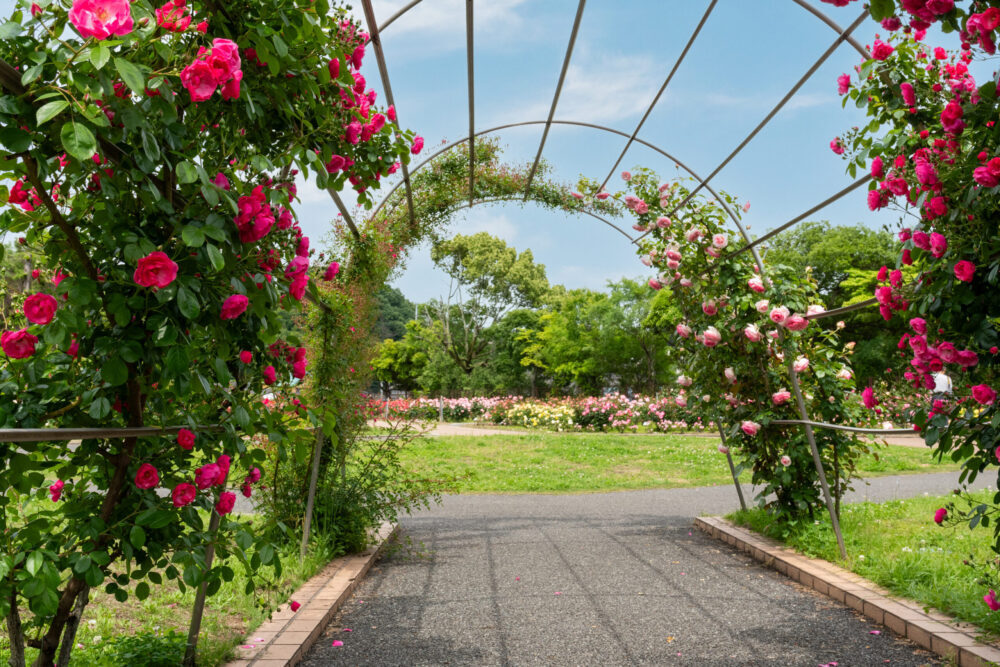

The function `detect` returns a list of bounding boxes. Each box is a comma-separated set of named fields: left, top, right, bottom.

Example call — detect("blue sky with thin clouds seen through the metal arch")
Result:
left=0, top=0, right=968, bottom=301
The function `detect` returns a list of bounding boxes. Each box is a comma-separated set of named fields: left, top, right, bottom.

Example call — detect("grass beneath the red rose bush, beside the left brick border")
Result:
left=0, top=545, right=331, bottom=667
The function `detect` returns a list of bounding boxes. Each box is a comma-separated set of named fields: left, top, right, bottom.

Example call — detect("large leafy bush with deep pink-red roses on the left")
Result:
left=0, top=0, right=413, bottom=665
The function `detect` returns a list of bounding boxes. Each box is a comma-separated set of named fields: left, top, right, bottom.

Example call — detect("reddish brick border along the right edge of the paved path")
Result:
left=694, top=516, right=1000, bottom=667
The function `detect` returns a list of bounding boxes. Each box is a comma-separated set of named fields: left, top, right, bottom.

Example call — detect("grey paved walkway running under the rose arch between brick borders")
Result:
left=304, top=473, right=988, bottom=667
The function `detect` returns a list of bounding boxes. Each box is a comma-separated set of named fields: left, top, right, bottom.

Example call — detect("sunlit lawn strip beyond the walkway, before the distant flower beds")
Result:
left=401, top=432, right=957, bottom=493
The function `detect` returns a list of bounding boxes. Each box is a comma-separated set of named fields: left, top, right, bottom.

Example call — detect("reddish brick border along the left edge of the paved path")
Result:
left=226, top=523, right=399, bottom=667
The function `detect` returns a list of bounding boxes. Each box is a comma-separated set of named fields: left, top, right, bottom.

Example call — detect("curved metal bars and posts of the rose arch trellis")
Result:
left=348, top=0, right=904, bottom=556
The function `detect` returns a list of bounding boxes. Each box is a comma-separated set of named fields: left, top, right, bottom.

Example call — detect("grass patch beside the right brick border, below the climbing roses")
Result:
left=727, top=491, right=1000, bottom=639
